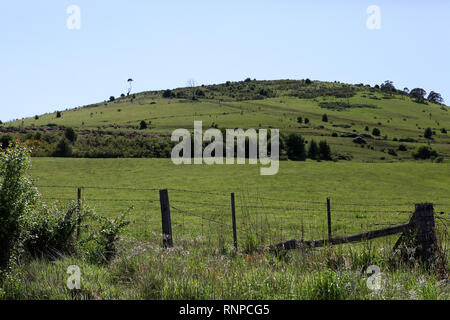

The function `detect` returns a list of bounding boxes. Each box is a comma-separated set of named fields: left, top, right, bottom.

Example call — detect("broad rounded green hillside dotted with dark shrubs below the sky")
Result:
left=0, top=79, right=450, bottom=161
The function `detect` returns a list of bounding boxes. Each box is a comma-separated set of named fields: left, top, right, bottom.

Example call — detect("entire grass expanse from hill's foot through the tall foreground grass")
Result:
left=0, top=158, right=450, bottom=300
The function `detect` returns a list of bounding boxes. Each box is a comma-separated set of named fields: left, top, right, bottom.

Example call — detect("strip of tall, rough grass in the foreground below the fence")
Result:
left=0, top=236, right=450, bottom=300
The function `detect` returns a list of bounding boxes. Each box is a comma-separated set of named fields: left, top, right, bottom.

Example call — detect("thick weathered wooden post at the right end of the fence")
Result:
left=414, top=203, right=437, bottom=262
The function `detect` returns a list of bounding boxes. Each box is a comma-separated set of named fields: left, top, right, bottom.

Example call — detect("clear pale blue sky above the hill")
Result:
left=0, top=0, right=450, bottom=122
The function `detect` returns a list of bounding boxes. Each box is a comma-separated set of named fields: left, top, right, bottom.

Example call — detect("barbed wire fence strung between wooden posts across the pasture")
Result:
left=37, top=185, right=450, bottom=255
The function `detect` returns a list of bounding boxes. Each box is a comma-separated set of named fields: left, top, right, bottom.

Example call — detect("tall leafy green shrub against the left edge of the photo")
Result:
left=0, top=143, right=37, bottom=271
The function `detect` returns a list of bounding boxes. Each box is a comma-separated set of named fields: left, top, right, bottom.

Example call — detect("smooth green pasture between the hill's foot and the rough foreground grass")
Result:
left=32, top=158, right=450, bottom=248
